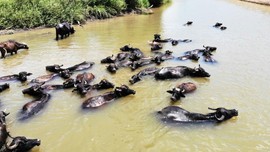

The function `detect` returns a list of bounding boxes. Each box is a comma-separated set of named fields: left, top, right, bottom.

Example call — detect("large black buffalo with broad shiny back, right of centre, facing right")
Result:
left=155, top=65, right=210, bottom=80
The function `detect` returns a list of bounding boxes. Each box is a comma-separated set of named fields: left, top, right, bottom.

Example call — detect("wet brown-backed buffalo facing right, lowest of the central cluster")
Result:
left=82, top=85, right=136, bottom=109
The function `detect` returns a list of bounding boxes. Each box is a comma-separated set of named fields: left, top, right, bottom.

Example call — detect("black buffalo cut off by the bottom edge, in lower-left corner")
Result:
left=6, top=136, right=40, bottom=152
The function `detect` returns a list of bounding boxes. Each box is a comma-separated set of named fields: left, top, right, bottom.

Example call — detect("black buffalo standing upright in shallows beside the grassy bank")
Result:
left=55, top=22, right=75, bottom=40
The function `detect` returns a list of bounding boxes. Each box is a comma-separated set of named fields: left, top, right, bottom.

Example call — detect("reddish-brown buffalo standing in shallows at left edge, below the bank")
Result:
left=0, top=40, right=29, bottom=58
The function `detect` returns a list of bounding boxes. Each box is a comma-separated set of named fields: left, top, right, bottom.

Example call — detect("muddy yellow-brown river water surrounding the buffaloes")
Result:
left=0, top=0, right=270, bottom=152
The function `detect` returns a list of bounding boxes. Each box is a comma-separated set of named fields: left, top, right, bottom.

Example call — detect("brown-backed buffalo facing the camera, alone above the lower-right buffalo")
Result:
left=167, top=82, right=197, bottom=101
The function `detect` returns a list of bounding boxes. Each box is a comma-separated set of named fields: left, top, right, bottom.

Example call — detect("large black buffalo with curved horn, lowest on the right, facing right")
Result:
left=158, top=106, right=238, bottom=123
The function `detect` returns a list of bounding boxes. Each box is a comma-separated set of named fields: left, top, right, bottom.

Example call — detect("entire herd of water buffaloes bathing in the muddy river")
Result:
left=0, top=21, right=238, bottom=152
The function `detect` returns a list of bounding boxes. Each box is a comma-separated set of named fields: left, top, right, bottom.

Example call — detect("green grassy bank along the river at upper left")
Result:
left=0, top=0, right=169, bottom=30
